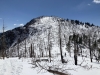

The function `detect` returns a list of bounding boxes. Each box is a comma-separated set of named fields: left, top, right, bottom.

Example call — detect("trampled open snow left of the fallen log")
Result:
left=0, top=58, right=53, bottom=75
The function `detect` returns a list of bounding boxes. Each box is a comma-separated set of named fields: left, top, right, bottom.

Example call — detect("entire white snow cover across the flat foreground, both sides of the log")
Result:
left=0, top=55, right=100, bottom=75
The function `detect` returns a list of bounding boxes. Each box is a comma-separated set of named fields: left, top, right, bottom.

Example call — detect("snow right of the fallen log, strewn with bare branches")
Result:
left=33, top=56, right=100, bottom=75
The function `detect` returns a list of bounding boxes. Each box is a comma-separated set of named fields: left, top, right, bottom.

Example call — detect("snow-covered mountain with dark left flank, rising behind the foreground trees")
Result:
left=0, top=16, right=100, bottom=56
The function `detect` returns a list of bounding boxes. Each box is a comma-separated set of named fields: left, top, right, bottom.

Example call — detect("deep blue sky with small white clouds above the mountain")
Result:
left=0, top=0, right=100, bottom=30
